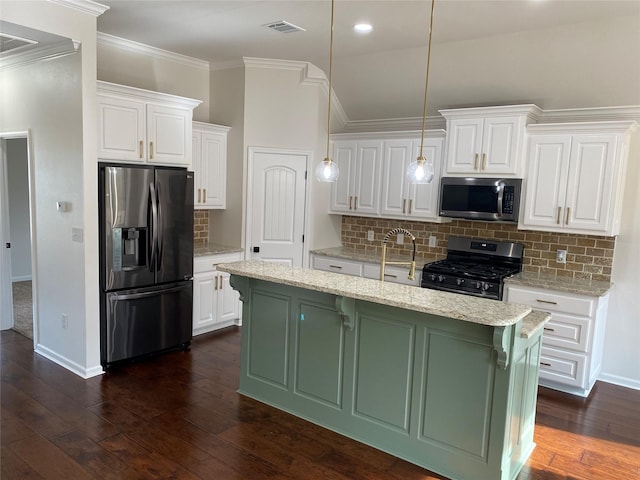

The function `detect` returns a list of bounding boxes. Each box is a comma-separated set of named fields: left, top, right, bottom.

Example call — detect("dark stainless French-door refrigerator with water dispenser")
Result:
left=98, top=163, right=193, bottom=368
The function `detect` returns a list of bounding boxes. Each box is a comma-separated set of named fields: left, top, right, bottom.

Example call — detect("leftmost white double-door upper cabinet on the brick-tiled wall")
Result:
left=331, top=139, right=382, bottom=215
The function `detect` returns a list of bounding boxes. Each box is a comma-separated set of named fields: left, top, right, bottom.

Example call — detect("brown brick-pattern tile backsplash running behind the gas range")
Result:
left=341, top=215, right=616, bottom=282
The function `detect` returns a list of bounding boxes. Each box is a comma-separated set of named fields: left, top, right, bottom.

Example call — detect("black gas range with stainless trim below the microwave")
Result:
left=421, top=237, right=524, bottom=300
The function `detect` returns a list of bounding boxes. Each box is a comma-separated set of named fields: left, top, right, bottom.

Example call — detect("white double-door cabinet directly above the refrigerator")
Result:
left=98, top=82, right=201, bottom=166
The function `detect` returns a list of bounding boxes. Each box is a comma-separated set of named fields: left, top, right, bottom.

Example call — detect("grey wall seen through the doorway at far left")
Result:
left=7, top=138, right=31, bottom=282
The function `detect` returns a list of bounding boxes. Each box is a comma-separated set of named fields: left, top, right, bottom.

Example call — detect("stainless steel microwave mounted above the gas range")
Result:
left=439, top=177, right=522, bottom=222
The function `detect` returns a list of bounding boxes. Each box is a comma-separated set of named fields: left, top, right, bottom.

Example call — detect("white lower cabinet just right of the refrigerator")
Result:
left=193, top=252, right=242, bottom=335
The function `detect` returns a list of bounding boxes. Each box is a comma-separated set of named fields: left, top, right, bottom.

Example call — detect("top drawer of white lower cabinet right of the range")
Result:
left=507, top=286, right=595, bottom=317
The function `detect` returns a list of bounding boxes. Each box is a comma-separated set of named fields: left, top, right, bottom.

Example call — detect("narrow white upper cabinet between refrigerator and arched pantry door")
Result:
left=193, top=122, right=231, bottom=209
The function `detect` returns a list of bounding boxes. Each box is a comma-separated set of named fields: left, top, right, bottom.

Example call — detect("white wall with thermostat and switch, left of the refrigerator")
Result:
left=0, top=0, right=102, bottom=376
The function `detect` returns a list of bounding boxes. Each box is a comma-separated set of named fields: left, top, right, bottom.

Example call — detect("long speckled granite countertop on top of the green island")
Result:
left=218, top=260, right=532, bottom=326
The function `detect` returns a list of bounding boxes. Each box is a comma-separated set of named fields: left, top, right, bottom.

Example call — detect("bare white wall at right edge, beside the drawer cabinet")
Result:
left=600, top=132, right=640, bottom=389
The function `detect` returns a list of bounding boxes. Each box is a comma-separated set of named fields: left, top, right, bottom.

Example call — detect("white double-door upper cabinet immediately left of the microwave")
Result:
left=380, top=135, right=444, bottom=221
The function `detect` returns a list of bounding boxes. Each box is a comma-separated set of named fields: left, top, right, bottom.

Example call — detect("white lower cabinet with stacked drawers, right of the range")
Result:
left=505, top=284, right=609, bottom=397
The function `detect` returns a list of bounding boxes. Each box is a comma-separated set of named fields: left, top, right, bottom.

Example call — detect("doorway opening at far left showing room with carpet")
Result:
left=0, top=133, right=34, bottom=340
